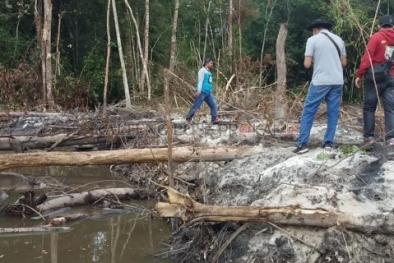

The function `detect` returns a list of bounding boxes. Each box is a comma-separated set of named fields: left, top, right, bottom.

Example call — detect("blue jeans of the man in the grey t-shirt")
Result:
left=298, top=84, right=343, bottom=145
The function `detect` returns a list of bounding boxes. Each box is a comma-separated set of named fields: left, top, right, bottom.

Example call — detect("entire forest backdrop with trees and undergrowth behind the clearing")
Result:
left=0, top=0, right=391, bottom=110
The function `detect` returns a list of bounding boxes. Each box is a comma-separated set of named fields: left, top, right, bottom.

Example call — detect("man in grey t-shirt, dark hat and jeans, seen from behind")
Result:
left=293, top=19, right=347, bottom=154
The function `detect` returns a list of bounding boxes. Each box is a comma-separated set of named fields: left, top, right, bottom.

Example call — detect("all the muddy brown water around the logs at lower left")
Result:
left=0, top=167, right=172, bottom=263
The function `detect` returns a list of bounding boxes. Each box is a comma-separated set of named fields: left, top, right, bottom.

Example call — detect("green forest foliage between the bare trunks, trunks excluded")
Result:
left=0, top=0, right=393, bottom=107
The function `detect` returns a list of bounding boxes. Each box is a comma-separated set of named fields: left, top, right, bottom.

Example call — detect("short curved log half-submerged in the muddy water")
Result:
left=37, top=188, right=140, bottom=213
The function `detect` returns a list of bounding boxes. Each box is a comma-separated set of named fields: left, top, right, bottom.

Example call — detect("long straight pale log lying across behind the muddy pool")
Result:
left=0, top=146, right=261, bottom=171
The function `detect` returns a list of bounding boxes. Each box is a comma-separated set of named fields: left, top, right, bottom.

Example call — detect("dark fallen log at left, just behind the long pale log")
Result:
left=0, top=133, right=135, bottom=151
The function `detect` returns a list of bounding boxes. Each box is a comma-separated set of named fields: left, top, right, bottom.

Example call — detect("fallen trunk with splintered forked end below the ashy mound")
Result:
left=155, top=188, right=394, bottom=234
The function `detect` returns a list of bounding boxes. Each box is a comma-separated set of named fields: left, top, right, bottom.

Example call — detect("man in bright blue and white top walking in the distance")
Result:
left=186, top=58, right=220, bottom=125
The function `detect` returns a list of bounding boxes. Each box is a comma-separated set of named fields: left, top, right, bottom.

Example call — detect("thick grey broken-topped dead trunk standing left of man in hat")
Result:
left=275, top=24, right=287, bottom=119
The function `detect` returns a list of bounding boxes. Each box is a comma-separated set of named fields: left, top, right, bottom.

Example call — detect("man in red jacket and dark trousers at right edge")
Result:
left=355, top=15, right=394, bottom=145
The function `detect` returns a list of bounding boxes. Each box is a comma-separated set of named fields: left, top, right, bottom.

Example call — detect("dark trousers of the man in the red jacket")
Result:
left=363, top=76, right=394, bottom=140
